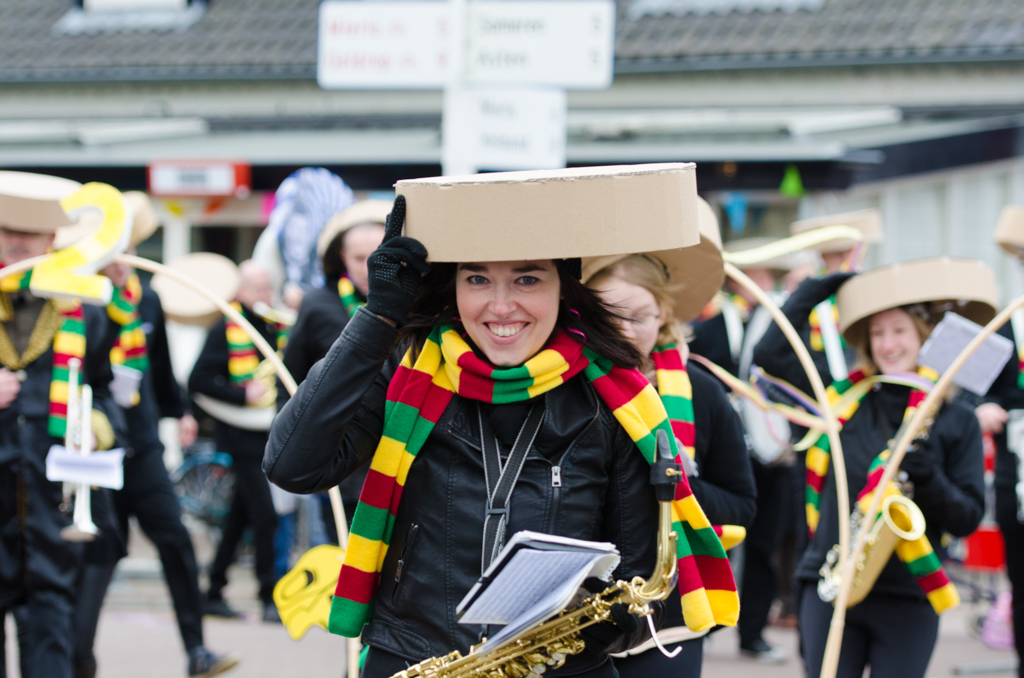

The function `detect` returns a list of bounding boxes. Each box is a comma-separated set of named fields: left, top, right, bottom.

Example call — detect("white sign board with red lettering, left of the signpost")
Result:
left=316, top=0, right=449, bottom=89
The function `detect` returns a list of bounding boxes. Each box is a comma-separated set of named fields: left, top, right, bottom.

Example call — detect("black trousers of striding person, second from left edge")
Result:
left=75, top=448, right=203, bottom=678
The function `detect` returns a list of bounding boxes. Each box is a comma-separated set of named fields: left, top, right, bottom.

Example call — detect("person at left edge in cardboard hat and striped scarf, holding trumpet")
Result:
left=0, top=172, right=125, bottom=678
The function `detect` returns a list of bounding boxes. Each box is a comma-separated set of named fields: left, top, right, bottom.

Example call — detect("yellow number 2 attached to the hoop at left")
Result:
left=30, top=182, right=131, bottom=305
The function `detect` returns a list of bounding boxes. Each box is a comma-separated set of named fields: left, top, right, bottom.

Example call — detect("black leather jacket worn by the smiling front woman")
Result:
left=263, top=308, right=663, bottom=675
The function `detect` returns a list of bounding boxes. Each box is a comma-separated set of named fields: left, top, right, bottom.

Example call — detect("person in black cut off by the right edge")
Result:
left=975, top=205, right=1024, bottom=676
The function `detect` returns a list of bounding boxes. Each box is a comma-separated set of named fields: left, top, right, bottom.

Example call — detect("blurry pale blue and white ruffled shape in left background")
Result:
left=253, top=167, right=355, bottom=309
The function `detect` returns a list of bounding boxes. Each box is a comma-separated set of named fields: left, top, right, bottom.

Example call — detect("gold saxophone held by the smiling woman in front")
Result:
left=391, top=430, right=682, bottom=678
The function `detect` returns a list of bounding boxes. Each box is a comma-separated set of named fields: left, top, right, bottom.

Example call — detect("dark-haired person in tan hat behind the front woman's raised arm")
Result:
left=278, top=200, right=391, bottom=532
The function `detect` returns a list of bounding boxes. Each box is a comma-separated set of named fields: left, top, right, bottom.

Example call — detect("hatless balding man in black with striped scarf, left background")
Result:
left=188, top=260, right=281, bottom=622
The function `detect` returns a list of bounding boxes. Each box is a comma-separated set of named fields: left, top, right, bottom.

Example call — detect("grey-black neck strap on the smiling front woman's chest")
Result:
left=476, top=405, right=545, bottom=574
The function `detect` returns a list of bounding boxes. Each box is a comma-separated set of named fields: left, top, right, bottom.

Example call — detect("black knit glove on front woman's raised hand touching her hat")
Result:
left=367, top=196, right=430, bottom=326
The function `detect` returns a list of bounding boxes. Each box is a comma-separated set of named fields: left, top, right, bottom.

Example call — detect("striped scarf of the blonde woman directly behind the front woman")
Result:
left=650, top=344, right=746, bottom=550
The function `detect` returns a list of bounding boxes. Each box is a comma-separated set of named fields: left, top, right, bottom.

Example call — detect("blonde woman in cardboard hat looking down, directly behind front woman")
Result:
left=583, top=199, right=755, bottom=678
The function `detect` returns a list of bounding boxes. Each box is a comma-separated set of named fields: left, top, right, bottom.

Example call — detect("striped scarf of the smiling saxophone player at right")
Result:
left=806, top=368, right=959, bottom=615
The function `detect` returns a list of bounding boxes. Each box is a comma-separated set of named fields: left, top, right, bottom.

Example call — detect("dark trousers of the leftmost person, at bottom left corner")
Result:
left=0, top=591, right=74, bottom=678
